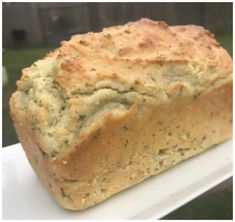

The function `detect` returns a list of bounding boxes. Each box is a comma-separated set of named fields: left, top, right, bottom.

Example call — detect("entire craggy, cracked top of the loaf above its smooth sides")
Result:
left=10, top=19, right=232, bottom=157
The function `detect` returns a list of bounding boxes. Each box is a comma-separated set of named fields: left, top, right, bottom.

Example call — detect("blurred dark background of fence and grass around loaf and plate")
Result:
left=2, top=2, right=233, bottom=219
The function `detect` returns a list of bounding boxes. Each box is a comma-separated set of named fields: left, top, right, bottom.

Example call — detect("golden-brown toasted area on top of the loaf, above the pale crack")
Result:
left=55, top=19, right=231, bottom=94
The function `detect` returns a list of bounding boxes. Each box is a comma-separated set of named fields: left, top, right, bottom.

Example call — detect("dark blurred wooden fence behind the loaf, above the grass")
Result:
left=3, top=3, right=232, bottom=47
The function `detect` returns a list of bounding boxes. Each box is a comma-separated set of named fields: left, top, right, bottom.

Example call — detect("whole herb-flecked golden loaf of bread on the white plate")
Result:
left=10, top=19, right=232, bottom=210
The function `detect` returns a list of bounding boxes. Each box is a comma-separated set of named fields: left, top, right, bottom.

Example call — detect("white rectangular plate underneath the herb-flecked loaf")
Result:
left=2, top=140, right=232, bottom=219
